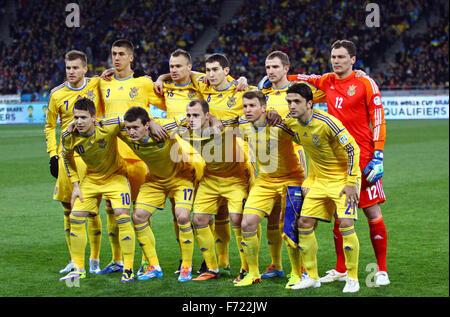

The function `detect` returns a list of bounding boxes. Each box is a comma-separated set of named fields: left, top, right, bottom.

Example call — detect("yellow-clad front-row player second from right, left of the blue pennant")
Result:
left=235, top=90, right=304, bottom=287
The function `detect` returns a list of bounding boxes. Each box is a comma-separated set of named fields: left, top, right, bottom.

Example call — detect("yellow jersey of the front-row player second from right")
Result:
left=239, top=116, right=304, bottom=182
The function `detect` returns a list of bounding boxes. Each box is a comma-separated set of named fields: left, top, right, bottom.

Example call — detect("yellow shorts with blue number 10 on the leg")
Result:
left=72, top=174, right=131, bottom=213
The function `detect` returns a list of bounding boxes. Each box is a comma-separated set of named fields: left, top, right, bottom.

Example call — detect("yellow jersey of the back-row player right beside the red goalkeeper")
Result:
left=261, top=81, right=327, bottom=118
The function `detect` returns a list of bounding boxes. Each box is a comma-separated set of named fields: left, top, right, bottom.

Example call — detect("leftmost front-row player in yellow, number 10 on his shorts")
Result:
left=60, top=98, right=135, bottom=282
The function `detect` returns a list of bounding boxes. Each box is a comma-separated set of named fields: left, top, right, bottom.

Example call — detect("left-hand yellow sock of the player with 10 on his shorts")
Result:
left=70, top=215, right=87, bottom=270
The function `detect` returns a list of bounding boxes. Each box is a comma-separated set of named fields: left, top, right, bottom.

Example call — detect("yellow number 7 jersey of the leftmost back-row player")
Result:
left=44, top=77, right=101, bottom=157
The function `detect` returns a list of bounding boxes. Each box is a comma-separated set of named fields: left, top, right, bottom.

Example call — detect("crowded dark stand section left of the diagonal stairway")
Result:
left=0, top=0, right=220, bottom=94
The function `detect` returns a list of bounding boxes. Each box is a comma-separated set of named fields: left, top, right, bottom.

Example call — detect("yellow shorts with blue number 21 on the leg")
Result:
left=301, top=179, right=358, bottom=222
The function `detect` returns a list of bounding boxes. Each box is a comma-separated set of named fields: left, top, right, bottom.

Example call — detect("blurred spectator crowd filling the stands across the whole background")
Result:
left=0, top=0, right=448, bottom=94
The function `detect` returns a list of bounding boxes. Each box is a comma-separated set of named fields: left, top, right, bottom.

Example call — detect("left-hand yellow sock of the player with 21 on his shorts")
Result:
left=298, top=228, right=319, bottom=280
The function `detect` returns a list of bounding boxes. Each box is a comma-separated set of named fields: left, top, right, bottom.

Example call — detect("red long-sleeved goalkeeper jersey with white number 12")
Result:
left=288, top=72, right=386, bottom=160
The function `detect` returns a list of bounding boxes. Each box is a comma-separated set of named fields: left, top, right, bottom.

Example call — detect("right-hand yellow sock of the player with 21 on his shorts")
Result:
left=339, top=226, right=359, bottom=280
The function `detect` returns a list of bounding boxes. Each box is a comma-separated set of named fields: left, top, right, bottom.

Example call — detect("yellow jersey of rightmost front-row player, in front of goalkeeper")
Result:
left=284, top=109, right=361, bottom=187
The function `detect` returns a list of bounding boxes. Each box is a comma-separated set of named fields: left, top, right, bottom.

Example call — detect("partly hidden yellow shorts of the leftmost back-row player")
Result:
left=53, top=155, right=86, bottom=204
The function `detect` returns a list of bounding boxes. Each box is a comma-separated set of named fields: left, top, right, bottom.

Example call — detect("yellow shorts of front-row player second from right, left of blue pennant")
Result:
left=244, top=178, right=302, bottom=218
